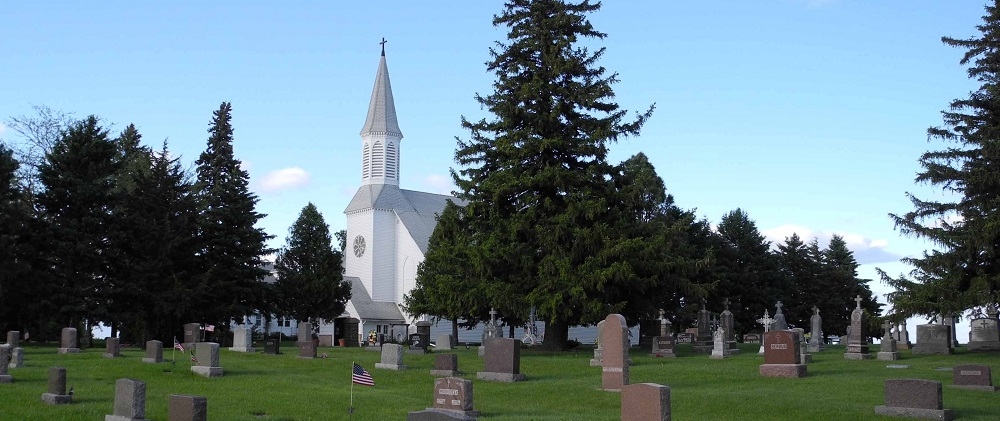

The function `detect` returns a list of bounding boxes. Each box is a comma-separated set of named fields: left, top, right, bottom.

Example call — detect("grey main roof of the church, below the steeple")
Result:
left=344, top=184, right=465, bottom=254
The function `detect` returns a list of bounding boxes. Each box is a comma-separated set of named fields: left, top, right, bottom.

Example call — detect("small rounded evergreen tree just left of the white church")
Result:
left=274, top=203, right=351, bottom=322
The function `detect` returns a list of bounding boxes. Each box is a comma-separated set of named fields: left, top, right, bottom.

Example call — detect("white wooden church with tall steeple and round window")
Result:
left=319, top=45, right=458, bottom=345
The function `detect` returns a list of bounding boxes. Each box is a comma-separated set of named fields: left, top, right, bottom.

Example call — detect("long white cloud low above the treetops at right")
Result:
left=761, top=224, right=903, bottom=265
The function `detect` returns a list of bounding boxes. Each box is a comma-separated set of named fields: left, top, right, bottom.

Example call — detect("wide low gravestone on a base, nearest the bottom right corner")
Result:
left=875, top=378, right=954, bottom=420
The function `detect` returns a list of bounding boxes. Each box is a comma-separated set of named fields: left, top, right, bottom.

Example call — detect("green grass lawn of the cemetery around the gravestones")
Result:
left=0, top=343, right=1000, bottom=421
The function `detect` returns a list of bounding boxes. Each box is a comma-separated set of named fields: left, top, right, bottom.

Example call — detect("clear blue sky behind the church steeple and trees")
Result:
left=0, top=0, right=984, bottom=324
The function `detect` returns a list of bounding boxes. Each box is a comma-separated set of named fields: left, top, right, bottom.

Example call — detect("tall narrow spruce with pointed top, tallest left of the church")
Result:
left=192, top=102, right=272, bottom=326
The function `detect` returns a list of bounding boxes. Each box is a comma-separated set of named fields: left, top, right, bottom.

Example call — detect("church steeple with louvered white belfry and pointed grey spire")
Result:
left=361, top=38, right=403, bottom=185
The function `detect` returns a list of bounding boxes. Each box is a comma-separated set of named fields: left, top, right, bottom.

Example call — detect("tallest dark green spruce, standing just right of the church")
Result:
left=453, top=0, right=652, bottom=349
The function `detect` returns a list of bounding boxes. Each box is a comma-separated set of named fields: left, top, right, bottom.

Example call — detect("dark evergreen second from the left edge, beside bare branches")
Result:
left=37, top=116, right=118, bottom=326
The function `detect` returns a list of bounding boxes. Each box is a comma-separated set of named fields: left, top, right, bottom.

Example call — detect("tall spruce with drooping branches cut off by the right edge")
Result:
left=881, top=1, right=1000, bottom=315
